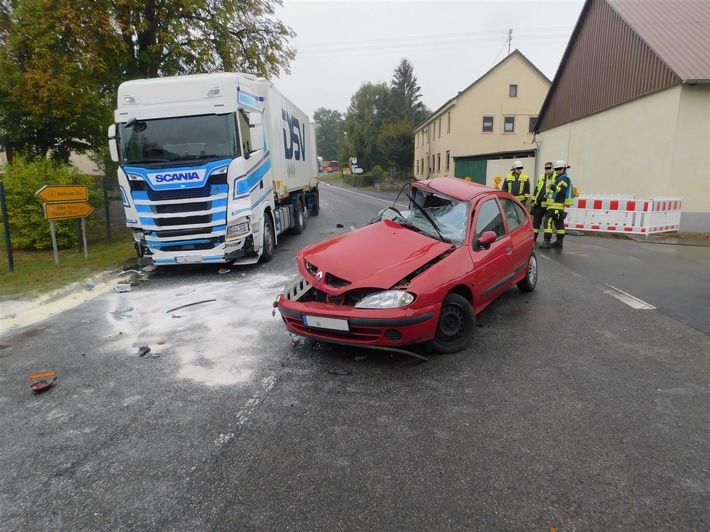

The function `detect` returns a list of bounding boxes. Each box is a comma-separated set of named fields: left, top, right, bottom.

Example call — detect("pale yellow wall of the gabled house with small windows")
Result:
left=414, top=53, right=549, bottom=178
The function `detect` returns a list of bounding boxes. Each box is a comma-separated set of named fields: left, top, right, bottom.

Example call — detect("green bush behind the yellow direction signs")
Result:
left=2, top=157, right=103, bottom=249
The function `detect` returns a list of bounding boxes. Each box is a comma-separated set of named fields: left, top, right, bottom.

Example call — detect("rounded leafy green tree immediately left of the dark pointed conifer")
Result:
left=341, top=83, right=391, bottom=169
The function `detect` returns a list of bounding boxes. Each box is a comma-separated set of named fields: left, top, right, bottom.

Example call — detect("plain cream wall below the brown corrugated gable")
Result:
left=537, top=85, right=710, bottom=230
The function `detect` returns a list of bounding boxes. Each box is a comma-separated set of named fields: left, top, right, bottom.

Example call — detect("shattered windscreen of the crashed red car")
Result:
left=377, top=188, right=468, bottom=246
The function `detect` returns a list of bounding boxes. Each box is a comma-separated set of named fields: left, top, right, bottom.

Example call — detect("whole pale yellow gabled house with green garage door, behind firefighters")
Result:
left=414, top=50, right=550, bottom=185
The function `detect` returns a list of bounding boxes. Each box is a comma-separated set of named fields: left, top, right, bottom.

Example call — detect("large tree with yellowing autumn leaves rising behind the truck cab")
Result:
left=0, top=0, right=295, bottom=160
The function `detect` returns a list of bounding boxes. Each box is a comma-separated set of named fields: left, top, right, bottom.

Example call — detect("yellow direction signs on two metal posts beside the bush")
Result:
left=35, top=185, right=94, bottom=265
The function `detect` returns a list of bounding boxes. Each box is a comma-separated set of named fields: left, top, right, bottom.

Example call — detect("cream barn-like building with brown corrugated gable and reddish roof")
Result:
left=536, top=0, right=710, bottom=231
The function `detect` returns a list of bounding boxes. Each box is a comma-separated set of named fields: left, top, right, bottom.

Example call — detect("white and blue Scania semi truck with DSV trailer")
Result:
left=108, top=73, right=319, bottom=265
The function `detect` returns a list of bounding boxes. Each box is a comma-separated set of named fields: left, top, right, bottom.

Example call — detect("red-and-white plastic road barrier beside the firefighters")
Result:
left=565, top=195, right=683, bottom=235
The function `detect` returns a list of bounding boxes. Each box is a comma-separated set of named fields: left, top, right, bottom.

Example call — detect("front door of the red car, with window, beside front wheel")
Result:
left=471, top=196, right=513, bottom=312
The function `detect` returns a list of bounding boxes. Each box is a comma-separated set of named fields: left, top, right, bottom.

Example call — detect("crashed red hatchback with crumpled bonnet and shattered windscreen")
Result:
left=278, top=177, right=538, bottom=353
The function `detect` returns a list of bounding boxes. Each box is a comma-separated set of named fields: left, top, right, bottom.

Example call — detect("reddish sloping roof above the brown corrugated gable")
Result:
left=606, top=0, right=710, bottom=83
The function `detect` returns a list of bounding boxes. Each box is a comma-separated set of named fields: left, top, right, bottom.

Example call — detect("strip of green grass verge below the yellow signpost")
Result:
left=0, top=236, right=136, bottom=301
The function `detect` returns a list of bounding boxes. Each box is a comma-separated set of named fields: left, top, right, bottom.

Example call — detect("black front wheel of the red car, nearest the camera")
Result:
left=430, top=294, right=476, bottom=354
